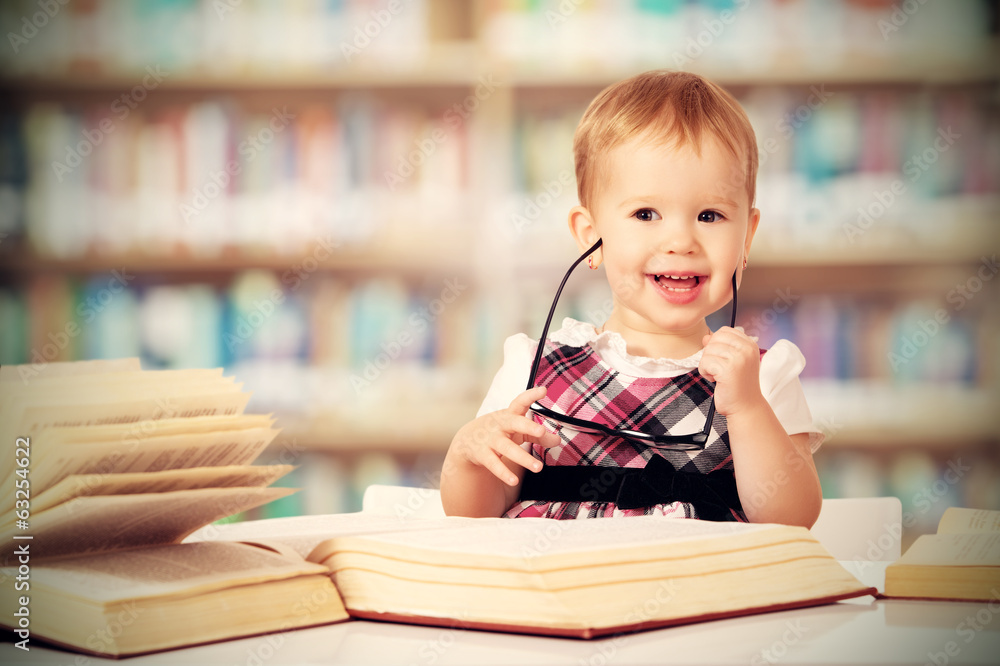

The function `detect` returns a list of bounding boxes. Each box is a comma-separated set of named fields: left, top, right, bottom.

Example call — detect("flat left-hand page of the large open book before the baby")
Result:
left=185, top=511, right=481, bottom=562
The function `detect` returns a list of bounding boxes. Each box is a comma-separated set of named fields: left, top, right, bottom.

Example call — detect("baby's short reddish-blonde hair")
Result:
left=573, top=69, right=757, bottom=207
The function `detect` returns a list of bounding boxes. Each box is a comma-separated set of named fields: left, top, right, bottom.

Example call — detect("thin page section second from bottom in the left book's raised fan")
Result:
left=0, top=465, right=295, bottom=526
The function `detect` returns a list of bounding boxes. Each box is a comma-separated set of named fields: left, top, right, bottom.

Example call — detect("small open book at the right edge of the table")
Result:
left=885, top=507, right=1000, bottom=601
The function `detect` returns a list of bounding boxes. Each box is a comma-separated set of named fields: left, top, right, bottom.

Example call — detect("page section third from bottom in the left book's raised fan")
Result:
left=0, top=428, right=279, bottom=513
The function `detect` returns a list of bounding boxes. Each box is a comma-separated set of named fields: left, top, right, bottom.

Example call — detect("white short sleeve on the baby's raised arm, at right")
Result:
left=760, top=340, right=825, bottom=452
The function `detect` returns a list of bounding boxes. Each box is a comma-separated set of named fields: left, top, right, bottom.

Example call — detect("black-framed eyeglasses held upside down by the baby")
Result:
left=525, top=240, right=736, bottom=451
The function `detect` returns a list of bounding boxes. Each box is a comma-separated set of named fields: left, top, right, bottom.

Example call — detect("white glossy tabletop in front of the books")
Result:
left=0, top=597, right=1000, bottom=666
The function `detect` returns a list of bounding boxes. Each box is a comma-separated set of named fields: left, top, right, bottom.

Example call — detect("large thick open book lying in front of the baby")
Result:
left=191, top=513, right=876, bottom=638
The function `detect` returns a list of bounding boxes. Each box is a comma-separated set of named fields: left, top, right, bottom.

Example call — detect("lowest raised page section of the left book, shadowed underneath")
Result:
left=0, top=488, right=295, bottom=562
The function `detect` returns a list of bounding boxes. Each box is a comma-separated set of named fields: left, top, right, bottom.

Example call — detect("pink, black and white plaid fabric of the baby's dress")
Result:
left=504, top=340, right=747, bottom=522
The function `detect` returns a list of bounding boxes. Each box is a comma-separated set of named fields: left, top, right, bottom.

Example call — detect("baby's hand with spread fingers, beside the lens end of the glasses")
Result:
left=449, top=386, right=562, bottom=486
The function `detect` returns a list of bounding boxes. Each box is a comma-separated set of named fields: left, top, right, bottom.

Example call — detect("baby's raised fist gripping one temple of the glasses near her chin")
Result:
left=698, top=326, right=764, bottom=416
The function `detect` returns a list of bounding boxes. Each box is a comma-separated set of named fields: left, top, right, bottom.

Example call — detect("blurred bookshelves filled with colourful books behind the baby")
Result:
left=0, top=0, right=1000, bottom=545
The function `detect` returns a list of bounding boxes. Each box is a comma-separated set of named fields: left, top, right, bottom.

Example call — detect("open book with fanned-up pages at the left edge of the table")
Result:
left=0, top=359, right=347, bottom=656
